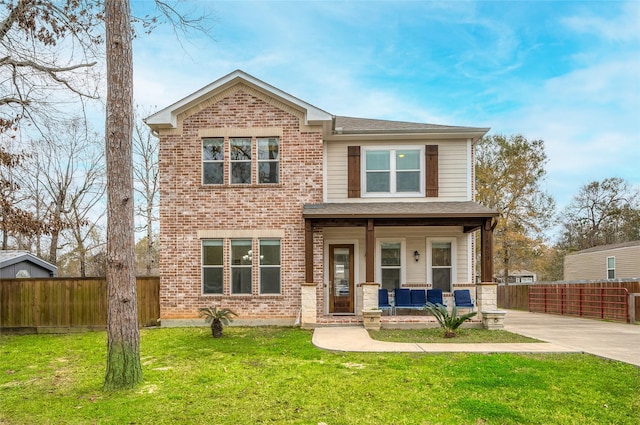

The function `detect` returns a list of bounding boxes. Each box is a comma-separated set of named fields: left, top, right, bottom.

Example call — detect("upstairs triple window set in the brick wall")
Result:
left=202, top=137, right=280, bottom=185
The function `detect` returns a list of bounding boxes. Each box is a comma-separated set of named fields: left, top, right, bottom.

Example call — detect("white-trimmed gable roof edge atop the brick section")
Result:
left=144, top=69, right=333, bottom=131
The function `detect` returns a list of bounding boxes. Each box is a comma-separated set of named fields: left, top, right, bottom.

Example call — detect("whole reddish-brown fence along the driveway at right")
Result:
left=498, top=280, right=640, bottom=322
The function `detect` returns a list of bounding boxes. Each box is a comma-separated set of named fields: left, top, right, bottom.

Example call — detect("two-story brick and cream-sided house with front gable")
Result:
left=146, top=71, right=498, bottom=323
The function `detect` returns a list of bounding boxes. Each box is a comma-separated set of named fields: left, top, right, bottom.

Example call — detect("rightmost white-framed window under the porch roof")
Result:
left=427, top=238, right=457, bottom=292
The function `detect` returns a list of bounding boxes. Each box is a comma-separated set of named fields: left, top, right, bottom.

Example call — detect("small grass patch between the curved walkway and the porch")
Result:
left=369, top=328, right=542, bottom=344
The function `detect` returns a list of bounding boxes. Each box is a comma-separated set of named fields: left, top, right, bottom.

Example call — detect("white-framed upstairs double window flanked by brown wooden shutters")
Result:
left=347, top=145, right=439, bottom=198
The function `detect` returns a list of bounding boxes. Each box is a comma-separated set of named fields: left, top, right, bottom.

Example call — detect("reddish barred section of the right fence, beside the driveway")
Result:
left=529, top=285, right=629, bottom=323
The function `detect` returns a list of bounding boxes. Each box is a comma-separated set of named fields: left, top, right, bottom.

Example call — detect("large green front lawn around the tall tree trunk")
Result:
left=0, top=327, right=640, bottom=425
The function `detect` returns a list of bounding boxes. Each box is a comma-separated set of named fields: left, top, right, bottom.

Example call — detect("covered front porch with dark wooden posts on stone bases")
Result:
left=300, top=201, right=498, bottom=327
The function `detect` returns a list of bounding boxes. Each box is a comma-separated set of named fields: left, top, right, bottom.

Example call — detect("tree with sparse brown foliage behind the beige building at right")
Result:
left=559, top=177, right=640, bottom=252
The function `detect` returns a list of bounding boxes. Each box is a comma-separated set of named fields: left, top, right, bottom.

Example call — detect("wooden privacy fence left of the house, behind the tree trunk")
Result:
left=0, top=277, right=160, bottom=333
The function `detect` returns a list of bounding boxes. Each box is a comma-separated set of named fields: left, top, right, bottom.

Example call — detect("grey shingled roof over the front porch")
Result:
left=303, top=201, right=498, bottom=218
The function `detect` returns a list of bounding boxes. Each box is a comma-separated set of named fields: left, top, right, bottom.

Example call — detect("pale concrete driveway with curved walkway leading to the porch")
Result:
left=313, top=310, right=640, bottom=366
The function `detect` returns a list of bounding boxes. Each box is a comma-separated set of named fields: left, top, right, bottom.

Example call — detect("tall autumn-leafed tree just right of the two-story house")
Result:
left=475, top=134, right=555, bottom=308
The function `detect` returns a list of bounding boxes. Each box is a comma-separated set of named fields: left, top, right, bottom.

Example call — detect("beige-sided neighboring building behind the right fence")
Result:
left=564, top=241, right=640, bottom=280
